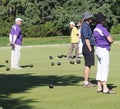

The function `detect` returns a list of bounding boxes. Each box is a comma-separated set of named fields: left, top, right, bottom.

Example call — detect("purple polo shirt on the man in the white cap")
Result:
left=10, top=24, right=23, bottom=45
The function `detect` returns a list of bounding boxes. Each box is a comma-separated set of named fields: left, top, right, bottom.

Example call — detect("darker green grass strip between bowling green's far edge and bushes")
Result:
left=0, top=34, right=120, bottom=47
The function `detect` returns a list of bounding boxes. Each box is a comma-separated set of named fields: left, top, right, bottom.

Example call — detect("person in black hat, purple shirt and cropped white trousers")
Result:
left=93, top=13, right=115, bottom=94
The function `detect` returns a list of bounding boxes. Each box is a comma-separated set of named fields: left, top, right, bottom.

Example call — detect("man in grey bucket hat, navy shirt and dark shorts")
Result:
left=81, top=12, right=96, bottom=88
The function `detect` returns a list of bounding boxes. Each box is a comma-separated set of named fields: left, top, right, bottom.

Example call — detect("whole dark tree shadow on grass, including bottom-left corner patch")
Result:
left=0, top=74, right=83, bottom=109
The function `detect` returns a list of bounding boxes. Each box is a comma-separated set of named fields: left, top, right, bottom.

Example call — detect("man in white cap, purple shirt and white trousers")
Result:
left=9, top=18, right=23, bottom=69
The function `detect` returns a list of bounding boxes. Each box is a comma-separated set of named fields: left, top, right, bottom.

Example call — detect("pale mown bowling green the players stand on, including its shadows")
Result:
left=0, top=43, right=120, bottom=109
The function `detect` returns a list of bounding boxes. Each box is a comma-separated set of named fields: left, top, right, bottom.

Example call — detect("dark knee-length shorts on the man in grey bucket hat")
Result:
left=83, top=45, right=95, bottom=67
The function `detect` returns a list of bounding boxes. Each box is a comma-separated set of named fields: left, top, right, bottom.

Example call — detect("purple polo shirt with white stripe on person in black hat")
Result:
left=93, top=24, right=110, bottom=51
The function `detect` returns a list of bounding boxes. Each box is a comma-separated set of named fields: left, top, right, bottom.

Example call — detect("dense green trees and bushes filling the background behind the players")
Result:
left=0, top=0, right=120, bottom=37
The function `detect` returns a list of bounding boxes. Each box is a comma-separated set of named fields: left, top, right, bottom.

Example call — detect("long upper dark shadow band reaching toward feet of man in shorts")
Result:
left=0, top=74, right=83, bottom=94
